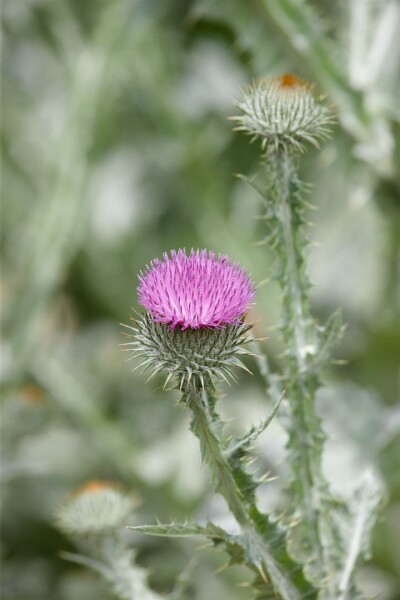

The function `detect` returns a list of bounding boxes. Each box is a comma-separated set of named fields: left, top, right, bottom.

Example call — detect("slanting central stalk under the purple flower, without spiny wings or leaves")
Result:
left=185, top=380, right=301, bottom=600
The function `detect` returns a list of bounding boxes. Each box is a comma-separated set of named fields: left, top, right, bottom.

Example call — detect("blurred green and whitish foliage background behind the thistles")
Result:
left=1, top=0, right=400, bottom=600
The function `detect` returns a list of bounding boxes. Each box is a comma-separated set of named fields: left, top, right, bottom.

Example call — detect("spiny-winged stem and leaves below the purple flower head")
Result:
left=134, top=376, right=316, bottom=600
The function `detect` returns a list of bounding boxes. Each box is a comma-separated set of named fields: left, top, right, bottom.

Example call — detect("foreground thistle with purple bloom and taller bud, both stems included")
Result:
left=124, top=75, right=381, bottom=600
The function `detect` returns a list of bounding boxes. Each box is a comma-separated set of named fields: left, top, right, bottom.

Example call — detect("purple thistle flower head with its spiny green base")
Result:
left=122, top=250, right=254, bottom=388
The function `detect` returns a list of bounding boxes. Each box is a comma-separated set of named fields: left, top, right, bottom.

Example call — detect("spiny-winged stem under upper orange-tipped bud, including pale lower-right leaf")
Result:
left=238, top=117, right=382, bottom=600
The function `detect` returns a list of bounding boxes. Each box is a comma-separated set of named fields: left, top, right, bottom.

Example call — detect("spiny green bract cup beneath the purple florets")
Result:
left=124, top=313, right=251, bottom=389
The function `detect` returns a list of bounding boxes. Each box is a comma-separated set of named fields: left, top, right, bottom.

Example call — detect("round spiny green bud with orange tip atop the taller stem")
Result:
left=232, top=74, right=334, bottom=152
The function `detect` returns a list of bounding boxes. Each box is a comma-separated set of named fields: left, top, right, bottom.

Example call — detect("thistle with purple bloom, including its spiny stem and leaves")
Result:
left=125, top=250, right=313, bottom=600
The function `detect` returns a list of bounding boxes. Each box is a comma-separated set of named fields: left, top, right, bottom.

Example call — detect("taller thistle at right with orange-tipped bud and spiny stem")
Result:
left=234, top=74, right=380, bottom=600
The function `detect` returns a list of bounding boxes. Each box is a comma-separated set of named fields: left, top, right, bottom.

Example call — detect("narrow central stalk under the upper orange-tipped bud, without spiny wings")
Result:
left=274, top=153, right=337, bottom=600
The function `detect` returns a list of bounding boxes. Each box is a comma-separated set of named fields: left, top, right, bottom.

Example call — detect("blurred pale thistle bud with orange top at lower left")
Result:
left=56, top=481, right=137, bottom=537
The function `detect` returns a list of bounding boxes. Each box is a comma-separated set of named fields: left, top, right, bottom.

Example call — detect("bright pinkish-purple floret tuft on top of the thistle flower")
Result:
left=138, top=249, right=254, bottom=329
